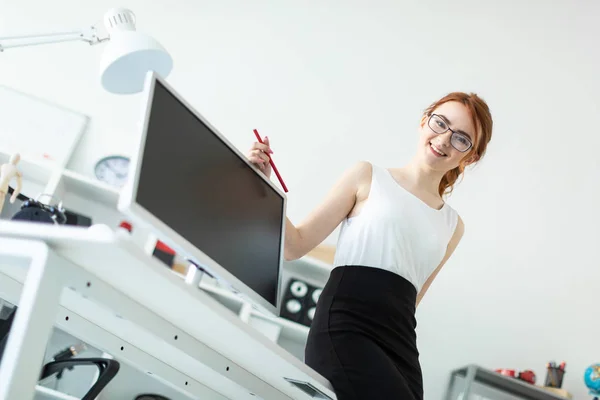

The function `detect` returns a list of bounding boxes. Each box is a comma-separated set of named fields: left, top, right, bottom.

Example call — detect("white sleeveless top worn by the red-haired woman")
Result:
left=333, top=165, right=458, bottom=293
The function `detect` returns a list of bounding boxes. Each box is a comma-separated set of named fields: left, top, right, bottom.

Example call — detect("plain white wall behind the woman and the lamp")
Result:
left=0, top=0, right=600, bottom=399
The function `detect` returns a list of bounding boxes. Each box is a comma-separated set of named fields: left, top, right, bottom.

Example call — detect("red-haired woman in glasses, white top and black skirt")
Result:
left=247, top=92, right=493, bottom=400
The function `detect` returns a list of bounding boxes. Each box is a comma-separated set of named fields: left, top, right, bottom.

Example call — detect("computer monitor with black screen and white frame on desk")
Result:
left=119, top=72, right=286, bottom=315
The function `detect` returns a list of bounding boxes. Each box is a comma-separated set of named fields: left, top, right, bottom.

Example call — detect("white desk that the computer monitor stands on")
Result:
left=0, top=221, right=336, bottom=400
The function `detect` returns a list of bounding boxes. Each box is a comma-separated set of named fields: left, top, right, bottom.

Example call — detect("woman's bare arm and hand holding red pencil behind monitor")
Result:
left=248, top=142, right=371, bottom=260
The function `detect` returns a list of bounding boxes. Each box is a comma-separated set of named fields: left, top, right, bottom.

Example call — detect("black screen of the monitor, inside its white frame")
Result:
left=135, top=81, right=284, bottom=306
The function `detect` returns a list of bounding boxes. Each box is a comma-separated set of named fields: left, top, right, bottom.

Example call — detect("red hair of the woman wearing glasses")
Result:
left=424, top=92, right=494, bottom=196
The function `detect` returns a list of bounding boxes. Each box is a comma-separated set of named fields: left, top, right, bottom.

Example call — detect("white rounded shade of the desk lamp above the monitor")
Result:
left=100, top=30, right=173, bottom=94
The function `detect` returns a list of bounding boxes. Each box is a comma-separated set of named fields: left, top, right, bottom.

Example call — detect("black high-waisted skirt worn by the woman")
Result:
left=305, top=266, right=423, bottom=400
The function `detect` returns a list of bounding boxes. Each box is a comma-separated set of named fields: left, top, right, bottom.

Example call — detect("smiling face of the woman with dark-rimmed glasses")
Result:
left=417, top=101, right=477, bottom=172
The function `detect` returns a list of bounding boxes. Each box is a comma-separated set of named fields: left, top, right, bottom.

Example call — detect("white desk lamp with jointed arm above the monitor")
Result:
left=0, top=8, right=173, bottom=94
